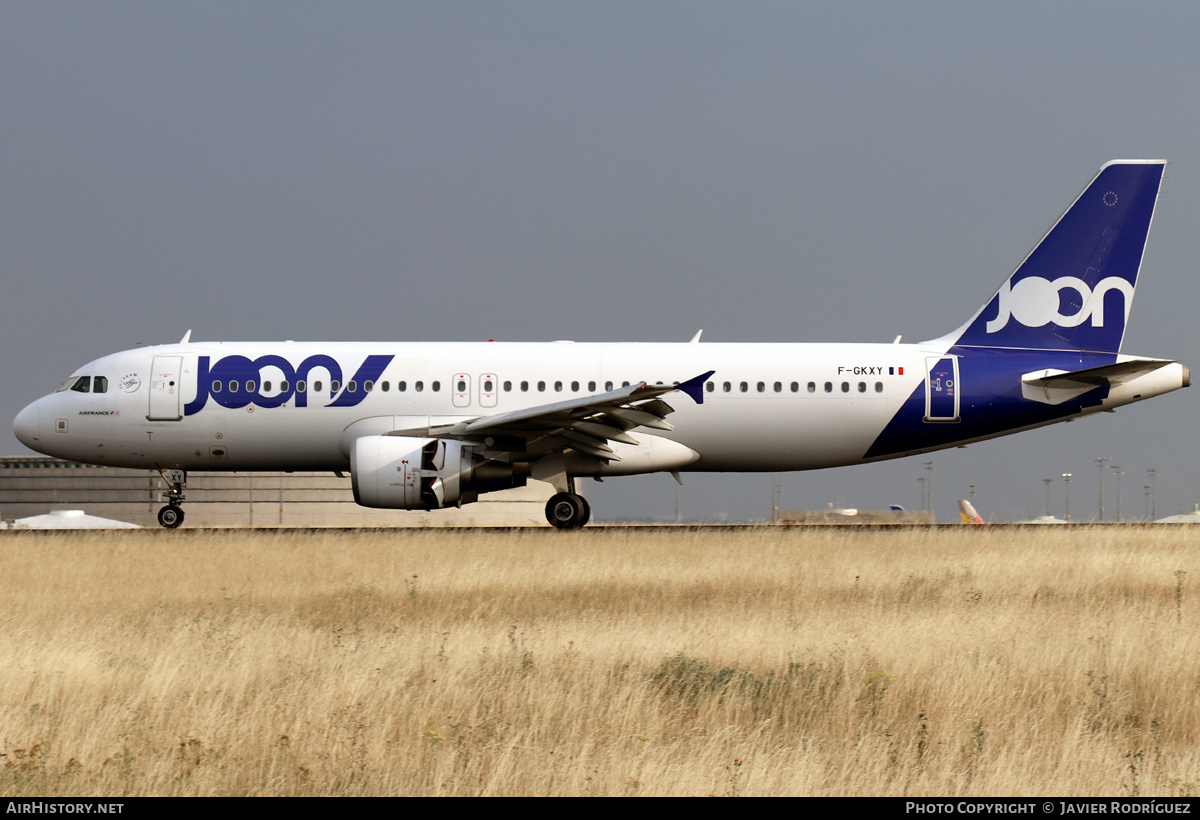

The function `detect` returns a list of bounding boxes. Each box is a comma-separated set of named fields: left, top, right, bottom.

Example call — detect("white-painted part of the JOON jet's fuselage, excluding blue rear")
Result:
left=16, top=342, right=944, bottom=473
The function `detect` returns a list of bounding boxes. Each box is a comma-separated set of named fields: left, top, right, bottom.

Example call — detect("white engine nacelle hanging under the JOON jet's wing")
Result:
left=350, top=436, right=524, bottom=509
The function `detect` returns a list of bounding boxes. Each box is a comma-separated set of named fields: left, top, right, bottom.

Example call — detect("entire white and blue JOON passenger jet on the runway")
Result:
left=13, top=160, right=1190, bottom=529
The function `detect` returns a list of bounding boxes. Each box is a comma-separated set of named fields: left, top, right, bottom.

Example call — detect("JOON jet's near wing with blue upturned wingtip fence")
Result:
left=386, top=370, right=715, bottom=462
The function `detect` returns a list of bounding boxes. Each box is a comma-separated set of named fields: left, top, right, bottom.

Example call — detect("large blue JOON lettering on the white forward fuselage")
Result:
left=184, top=353, right=394, bottom=415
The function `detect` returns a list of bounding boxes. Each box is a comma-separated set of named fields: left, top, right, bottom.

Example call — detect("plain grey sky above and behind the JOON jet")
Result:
left=0, top=2, right=1200, bottom=519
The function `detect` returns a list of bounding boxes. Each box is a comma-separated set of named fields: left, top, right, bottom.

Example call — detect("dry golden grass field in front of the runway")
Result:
left=0, top=527, right=1200, bottom=797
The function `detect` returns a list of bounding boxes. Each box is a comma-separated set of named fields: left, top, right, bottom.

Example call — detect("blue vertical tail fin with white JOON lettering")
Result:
left=950, top=160, right=1166, bottom=353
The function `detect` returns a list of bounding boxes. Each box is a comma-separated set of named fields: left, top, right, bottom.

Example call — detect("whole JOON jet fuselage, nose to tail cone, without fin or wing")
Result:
left=14, top=341, right=1189, bottom=485
